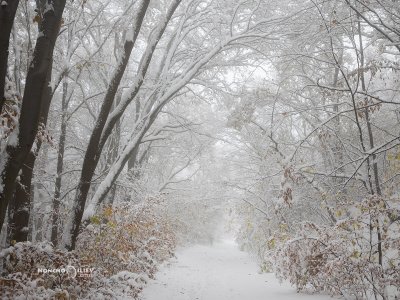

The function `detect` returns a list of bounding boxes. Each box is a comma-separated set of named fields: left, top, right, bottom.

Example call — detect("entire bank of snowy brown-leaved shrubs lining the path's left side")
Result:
left=0, top=198, right=175, bottom=300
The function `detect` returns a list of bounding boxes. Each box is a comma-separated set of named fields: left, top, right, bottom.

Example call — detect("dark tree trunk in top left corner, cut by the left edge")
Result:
left=0, top=0, right=19, bottom=112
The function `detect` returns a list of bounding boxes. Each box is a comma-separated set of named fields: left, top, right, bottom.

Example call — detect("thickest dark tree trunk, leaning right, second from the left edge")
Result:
left=0, top=0, right=65, bottom=232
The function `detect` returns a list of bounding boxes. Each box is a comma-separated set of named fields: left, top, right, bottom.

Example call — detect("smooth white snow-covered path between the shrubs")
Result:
left=141, top=240, right=333, bottom=300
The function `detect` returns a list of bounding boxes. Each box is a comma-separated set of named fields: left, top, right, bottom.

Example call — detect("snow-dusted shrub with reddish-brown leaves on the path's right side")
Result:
left=272, top=197, right=400, bottom=300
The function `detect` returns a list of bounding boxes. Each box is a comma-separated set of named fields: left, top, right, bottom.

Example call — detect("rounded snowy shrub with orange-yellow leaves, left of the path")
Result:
left=77, top=198, right=176, bottom=277
